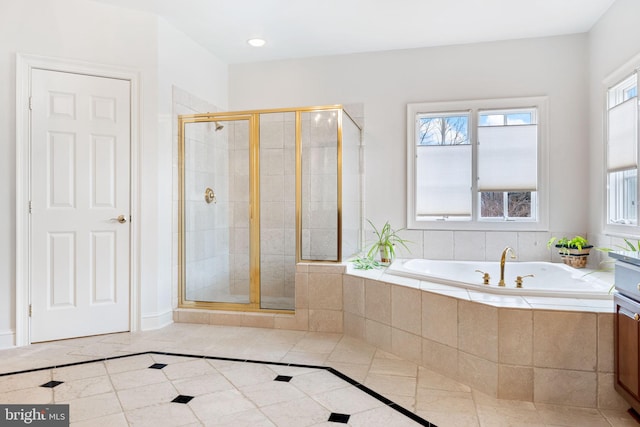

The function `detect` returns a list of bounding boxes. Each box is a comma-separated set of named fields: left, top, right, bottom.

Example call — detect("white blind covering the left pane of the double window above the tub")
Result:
left=416, top=144, right=471, bottom=216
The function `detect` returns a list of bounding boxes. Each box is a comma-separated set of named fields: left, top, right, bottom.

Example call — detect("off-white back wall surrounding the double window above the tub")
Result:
left=229, top=34, right=589, bottom=260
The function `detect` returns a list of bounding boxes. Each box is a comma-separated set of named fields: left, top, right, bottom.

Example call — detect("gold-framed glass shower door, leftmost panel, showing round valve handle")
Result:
left=179, top=118, right=251, bottom=305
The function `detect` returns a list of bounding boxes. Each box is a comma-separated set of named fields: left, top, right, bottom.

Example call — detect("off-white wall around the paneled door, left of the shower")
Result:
left=0, top=0, right=227, bottom=348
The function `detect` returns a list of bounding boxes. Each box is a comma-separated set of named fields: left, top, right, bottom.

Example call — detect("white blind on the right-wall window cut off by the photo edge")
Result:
left=607, top=97, right=638, bottom=172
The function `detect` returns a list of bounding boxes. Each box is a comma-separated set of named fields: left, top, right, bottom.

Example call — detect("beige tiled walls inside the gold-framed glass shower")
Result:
left=173, top=99, right=363, bottom=309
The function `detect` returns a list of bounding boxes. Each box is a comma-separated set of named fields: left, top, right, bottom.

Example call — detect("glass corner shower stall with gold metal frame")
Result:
left=178, top=105, right=363, bottom=312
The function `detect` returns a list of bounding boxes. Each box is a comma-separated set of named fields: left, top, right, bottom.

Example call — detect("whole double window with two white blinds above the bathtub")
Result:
left=407, top=98, right=546, bottom=230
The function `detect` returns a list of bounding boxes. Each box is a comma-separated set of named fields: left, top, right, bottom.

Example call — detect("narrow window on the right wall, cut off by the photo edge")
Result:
left=607, top=72, right=638, bottom=225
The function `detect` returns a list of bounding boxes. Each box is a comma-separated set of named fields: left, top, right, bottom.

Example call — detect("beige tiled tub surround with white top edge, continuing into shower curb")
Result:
left=179, top=264, right=627, bottom=409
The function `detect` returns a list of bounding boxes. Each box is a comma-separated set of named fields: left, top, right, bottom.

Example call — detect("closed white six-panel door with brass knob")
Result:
left=29, top=69, right=131, bottom=342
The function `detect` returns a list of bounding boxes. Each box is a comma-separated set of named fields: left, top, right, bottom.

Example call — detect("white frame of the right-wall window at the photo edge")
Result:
left=602, top=55, right=640, bottom=237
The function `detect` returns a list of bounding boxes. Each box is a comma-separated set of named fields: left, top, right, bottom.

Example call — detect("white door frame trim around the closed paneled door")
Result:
left=15, top=53, right=142, bottom=346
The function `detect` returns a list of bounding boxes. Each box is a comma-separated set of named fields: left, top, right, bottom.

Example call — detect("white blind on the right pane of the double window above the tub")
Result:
left=478, top=125, right=538, bottom=191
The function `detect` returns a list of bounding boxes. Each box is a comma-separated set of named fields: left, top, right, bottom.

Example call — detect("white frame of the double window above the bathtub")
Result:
left=407, top=96, right=549, bottom=231
